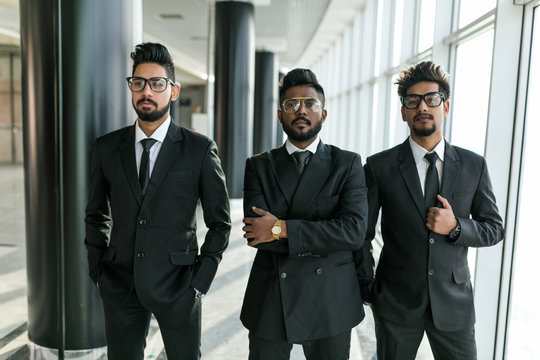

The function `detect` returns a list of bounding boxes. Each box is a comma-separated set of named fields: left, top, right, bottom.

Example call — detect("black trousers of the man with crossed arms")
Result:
left=249, top=330, right=351, bottom=360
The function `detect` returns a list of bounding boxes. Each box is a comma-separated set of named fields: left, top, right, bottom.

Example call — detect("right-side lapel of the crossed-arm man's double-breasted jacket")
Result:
left=290, top=141, right=335, bottom=213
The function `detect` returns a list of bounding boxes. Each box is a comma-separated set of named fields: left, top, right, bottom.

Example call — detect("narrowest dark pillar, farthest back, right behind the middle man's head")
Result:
left=253, top=51, right=279, bottom=154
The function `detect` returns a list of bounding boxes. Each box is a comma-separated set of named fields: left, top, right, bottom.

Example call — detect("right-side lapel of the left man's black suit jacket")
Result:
left=141, top=121, right=182, bottom=207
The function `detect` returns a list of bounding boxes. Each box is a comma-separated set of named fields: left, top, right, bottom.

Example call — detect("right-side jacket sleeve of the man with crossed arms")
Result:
left=287, top=155, right=367, bottom=256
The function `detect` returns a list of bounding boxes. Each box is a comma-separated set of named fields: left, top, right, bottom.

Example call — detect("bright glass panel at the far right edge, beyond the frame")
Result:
left=506, top=8, right=540, bottom=359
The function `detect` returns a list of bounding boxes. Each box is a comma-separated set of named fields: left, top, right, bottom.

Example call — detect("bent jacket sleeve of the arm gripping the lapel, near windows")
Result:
left=450, top=159, right=504, bottom=247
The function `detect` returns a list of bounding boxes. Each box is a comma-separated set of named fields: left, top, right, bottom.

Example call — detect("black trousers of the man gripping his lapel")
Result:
left=373, top=311, right=476, bottom=360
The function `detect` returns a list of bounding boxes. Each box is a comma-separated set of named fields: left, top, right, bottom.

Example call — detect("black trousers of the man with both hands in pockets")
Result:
left=103, top=288, right=201, bottom=360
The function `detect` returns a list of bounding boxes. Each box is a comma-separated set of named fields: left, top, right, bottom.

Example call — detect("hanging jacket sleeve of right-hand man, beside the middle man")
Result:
left=354, top=158, right=381, bottom=302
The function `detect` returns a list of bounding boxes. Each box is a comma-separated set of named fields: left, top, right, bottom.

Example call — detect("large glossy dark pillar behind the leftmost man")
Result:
left=20, top=0, right=141, bottom=352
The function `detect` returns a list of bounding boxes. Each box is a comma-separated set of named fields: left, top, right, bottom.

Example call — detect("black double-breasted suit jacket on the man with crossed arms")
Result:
left=240, top=142, right=367, bottom=342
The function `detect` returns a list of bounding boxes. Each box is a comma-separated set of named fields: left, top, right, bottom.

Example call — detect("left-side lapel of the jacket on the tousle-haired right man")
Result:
left=398, top=138, right=426, bottom=219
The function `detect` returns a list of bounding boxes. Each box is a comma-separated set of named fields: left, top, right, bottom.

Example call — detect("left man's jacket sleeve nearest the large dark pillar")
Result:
left=85, top=141, right=111, bottom=283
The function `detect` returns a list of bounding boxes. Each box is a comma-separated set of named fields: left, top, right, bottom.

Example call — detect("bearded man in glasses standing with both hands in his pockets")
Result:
left=85, top=43, right=231, bottom=360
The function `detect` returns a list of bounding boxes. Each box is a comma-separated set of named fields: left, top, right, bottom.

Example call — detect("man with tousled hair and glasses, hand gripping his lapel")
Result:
left=358, top=61, right=504, bottom=360
